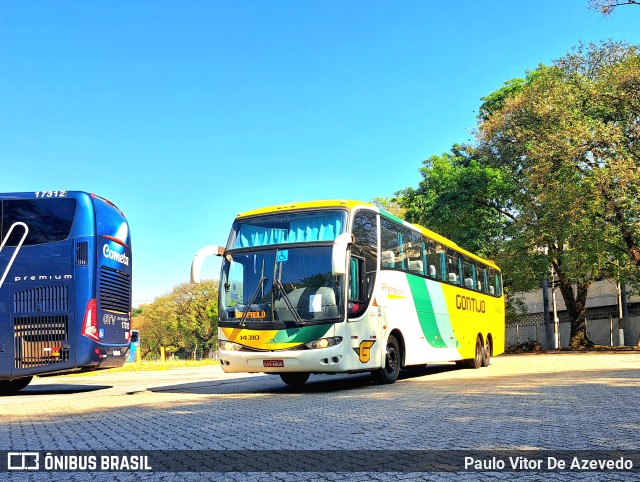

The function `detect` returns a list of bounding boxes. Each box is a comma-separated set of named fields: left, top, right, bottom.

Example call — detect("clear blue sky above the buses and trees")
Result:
left=0, top=0, right=640, bottom=305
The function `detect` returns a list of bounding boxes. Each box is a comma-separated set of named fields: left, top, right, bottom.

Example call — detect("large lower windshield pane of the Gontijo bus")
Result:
left=220, top=246, right=344, bottom=327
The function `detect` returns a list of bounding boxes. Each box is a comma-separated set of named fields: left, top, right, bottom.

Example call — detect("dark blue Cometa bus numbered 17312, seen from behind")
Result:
left=0, top=191, right=132, bottom=394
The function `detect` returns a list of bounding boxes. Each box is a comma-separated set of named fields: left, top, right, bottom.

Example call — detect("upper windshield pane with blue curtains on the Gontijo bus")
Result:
left=227, top=211, right=346, bottom=249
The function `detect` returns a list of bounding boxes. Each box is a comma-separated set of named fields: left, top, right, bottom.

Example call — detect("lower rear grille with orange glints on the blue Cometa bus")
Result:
left=13, top=315, right=69, bottom=369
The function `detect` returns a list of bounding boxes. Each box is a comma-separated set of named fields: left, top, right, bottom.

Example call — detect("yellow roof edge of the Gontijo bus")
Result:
left=237, top=200, right=500, bottom=270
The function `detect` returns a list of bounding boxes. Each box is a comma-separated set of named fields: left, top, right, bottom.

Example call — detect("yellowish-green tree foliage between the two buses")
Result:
left=133, top=281, right=218, bottom=358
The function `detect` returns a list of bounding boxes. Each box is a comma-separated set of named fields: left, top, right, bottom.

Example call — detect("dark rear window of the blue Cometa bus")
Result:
left=0, top=198, right=76, bottom=246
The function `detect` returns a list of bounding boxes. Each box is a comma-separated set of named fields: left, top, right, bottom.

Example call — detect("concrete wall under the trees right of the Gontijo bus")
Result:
left=506, top=316, right=640, bottom=349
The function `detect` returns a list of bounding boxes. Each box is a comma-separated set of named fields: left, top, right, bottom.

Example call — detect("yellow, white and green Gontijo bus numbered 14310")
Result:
left=191, top=201, right=505, bottom=385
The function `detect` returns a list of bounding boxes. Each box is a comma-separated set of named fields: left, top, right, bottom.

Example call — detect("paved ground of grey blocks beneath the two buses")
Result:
left=0, top=353, right=640, bottom=480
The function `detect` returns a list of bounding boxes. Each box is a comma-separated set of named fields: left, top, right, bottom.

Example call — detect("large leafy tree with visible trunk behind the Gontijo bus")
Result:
left=400, top=42, right=640, bottom=346
